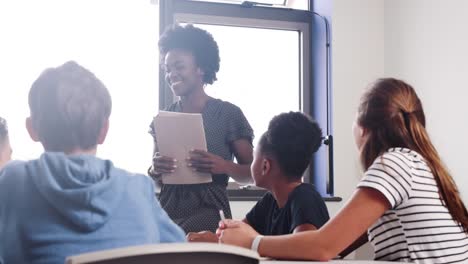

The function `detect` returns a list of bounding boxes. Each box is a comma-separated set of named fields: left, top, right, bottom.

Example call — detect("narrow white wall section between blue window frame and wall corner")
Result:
left=319, top=0, right=384, bottom=215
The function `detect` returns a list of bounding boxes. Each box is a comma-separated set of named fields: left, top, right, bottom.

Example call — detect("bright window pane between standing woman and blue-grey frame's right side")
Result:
left=192, top=24, right=301, bottom=167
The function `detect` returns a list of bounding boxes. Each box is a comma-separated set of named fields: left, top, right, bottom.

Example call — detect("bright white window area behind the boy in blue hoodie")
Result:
left=0, top=0, right=159, bottom=173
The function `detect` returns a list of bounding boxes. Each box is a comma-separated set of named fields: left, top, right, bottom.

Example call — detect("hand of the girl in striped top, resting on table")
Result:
left=216, top=219, right=259, bottom=249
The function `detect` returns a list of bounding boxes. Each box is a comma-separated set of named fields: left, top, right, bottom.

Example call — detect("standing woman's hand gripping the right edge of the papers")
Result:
left=187, top=149, right=227, bottom=174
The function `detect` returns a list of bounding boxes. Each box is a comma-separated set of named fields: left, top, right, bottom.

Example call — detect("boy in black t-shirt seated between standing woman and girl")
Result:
left=188, top=112, right=329, bottom=242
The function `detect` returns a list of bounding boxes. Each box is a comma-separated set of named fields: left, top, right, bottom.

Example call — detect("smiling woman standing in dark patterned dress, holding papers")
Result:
left=148, top=25, right=253, bottom=232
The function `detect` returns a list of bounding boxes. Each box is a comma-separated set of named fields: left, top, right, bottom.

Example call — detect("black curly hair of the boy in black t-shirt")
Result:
left=258, top=112, right=322, bottom=180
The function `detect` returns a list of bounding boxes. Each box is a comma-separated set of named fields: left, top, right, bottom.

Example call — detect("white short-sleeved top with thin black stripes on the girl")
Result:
left=358, top=148, right=468, bottom=264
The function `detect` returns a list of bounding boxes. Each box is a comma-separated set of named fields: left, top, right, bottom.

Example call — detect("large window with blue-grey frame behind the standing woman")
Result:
left=160, top=0, right=332, bottom=198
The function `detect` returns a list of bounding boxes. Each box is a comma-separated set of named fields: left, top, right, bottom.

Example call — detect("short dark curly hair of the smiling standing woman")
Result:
left=158, top=24, right=220, bottom=84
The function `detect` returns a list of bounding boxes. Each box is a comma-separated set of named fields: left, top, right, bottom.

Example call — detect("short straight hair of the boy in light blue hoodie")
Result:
left=29, top=61, right=112, bottom=152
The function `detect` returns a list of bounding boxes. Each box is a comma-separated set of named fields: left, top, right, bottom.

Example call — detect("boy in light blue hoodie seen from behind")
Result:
left=0, top=62, right=185, bottom=264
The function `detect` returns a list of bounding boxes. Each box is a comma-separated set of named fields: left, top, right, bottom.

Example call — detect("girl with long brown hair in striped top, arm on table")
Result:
left=218, top=78, right=468, bottom=263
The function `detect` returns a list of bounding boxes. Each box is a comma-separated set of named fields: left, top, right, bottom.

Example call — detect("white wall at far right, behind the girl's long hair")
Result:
left=385, top=0, right=468, bottom=204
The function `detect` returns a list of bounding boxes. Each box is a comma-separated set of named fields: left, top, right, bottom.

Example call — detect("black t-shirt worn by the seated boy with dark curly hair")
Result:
left=246, top=183, right=330, bottom=235
